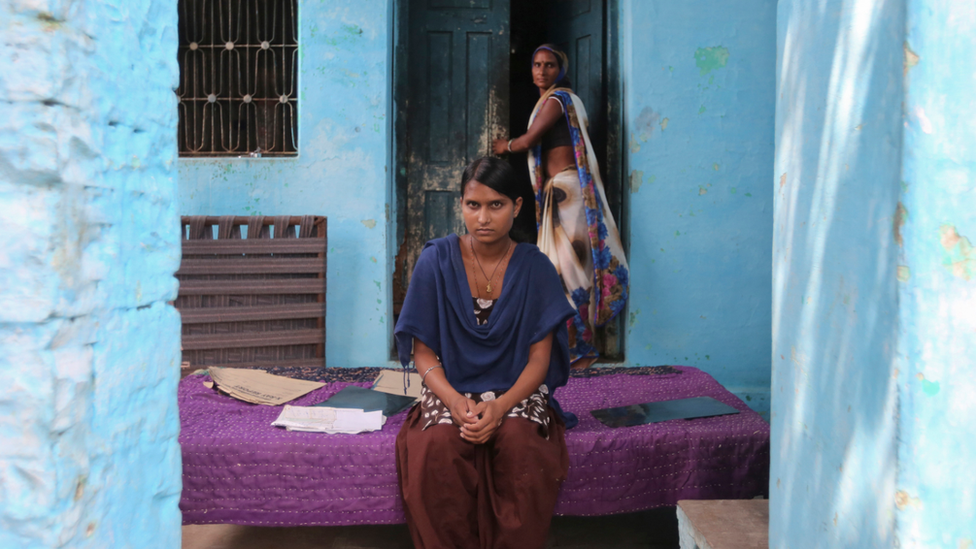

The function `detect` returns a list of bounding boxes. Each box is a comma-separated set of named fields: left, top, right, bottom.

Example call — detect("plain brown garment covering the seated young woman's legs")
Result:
left=396, top=400, right=569, bottom=549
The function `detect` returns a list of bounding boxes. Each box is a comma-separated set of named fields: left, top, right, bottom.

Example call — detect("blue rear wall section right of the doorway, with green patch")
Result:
left=620, top=0, right=776, bottom=411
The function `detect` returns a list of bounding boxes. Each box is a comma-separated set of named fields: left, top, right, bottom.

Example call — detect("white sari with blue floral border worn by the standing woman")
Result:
left=529, top=88, right=630, bottom=362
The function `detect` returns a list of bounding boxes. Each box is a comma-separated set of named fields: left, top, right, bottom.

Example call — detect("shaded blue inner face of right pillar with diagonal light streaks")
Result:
left=769, top=0, right=905, bottom=548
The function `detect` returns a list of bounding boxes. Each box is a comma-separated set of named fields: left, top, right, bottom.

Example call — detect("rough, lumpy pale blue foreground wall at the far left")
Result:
left=0, top=0, right=181, bottom=548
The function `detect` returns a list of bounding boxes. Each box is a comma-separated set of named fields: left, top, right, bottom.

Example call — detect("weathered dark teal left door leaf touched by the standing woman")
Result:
left=395, top=0, right=509, bottom=297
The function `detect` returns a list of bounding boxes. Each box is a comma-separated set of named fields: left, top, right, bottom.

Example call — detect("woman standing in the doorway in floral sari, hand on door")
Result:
left=492, top=44, right=630, bottom=368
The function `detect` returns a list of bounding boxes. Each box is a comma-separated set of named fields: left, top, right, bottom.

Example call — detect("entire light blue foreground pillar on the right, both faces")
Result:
left=770, top=0, right=976, bottom=548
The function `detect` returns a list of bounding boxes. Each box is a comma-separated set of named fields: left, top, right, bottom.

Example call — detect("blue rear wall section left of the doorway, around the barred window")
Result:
left=178, top=0, right=395, bottom=367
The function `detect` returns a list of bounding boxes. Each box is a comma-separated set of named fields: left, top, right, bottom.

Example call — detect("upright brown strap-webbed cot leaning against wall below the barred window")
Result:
left=175, top=216, right=328, bottom=371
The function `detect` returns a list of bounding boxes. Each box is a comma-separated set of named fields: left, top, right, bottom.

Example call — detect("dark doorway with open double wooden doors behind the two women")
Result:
left=391, top=0, right=628, bottom=362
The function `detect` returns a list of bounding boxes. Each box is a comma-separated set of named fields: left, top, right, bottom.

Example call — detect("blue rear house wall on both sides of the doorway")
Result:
left=179, top=0, right=775, bottom=411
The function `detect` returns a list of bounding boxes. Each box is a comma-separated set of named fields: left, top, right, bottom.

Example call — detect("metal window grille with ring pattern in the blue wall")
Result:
left=176, top=0, right=298, bottom=157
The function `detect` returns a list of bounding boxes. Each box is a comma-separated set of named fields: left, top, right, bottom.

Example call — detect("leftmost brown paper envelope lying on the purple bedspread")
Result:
left=207, top=366, right=325, bottom=406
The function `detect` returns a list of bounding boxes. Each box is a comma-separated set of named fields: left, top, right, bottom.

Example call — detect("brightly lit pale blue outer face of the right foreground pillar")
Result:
left=894, top=0, right=976, bottom=548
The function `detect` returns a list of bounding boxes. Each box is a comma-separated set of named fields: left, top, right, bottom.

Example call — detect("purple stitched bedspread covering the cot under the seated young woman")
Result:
left=179, top=366, right=769, bottom=526
